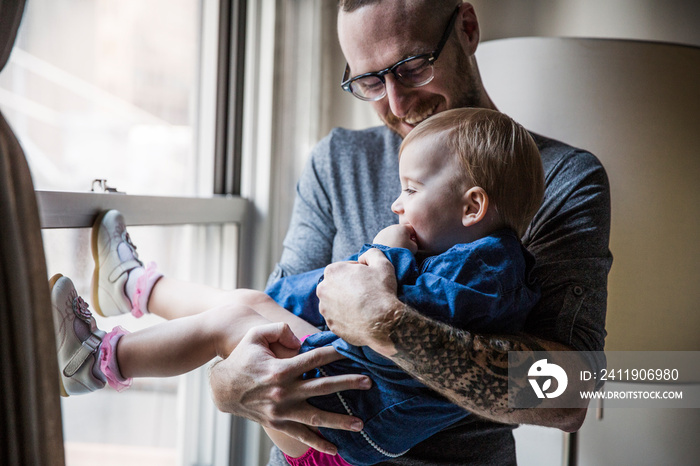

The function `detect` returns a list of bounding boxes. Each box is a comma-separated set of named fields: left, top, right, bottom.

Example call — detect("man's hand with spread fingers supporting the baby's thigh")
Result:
left=210, top=323, right=371, bottom=454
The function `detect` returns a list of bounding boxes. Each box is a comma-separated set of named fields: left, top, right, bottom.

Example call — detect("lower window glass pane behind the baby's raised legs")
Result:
left=42, top=226, right=237, bottom=466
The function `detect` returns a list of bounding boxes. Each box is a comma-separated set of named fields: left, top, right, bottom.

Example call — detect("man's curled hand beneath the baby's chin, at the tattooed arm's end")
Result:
left=316, top=249, right=404, bottom=356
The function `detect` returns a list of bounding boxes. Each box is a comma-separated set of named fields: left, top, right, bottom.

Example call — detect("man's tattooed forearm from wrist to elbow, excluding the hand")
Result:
left=385, top=306, right=586, bottom=431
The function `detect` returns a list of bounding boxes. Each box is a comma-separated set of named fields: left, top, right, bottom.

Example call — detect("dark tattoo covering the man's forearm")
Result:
left=389, top=308, right=544, bottom=415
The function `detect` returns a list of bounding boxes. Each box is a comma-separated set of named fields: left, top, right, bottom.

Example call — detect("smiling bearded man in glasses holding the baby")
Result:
left=212, top=0, right=612, bottom=465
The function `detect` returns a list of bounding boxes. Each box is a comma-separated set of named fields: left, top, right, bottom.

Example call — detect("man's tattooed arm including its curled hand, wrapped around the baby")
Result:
left=317, top=251, right=592, bottom=432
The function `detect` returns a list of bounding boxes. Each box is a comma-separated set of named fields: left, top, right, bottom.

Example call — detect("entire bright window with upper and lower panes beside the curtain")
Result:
left=0, top=0, right=249, bottom=465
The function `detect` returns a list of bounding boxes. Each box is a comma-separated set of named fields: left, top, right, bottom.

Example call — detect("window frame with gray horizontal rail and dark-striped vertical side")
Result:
left=29, top=0, right=260, bottom=465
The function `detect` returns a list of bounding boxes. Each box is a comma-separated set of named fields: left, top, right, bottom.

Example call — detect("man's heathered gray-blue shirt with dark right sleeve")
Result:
left=269, top=126, right=612, bottom=466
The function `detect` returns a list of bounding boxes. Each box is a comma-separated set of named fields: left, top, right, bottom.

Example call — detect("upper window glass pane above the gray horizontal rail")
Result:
left=0, top=0, right=202, bottom=195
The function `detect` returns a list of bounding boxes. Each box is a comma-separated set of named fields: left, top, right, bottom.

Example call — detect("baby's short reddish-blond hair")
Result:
left=399, top=108, right=544, bottom=237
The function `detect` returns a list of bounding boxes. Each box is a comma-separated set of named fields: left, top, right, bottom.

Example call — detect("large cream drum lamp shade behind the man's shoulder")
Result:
left=477, top=38, right=700, bottom=351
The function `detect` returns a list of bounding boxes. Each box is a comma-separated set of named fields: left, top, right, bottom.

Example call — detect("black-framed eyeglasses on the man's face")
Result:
left=340, top=7, right=459, bottom=101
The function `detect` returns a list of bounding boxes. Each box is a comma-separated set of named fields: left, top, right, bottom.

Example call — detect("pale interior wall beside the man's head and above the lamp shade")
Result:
left=319, top=0, right=700, bottom=135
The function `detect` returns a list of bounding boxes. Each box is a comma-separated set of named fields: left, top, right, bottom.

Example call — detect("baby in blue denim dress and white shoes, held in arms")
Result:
left=51, top=109, right=544, bottom=465
